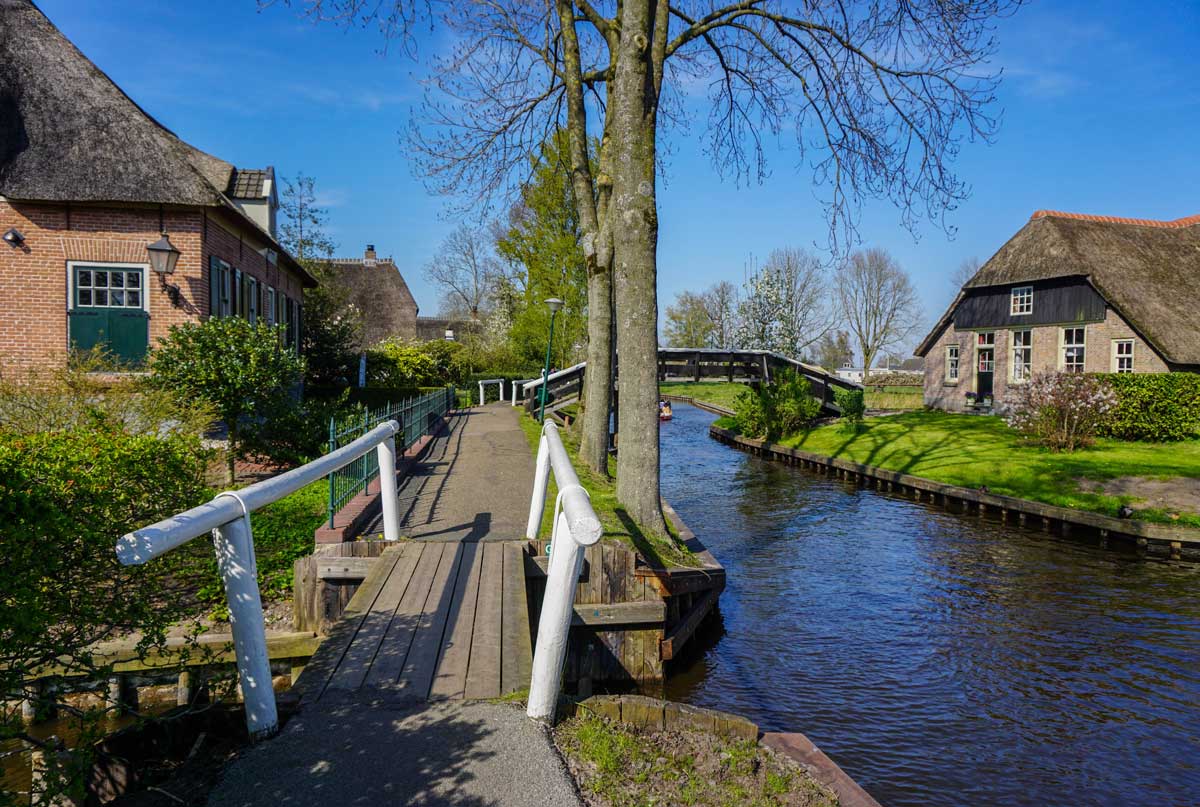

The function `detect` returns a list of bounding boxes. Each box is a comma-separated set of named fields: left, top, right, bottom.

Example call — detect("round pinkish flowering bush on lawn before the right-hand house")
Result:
left=1003, top=372, right=1117, bottom=452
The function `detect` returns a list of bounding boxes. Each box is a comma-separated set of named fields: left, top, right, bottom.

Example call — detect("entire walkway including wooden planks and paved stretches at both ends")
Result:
left=209, top=405, right=581, bottom=807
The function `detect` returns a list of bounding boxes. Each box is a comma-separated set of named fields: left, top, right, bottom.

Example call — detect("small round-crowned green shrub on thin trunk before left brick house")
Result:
left=149, top=317, right=305, bottom=480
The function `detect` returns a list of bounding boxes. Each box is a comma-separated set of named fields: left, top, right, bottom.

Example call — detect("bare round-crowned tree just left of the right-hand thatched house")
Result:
left=834, top=249, right=922, bottom=382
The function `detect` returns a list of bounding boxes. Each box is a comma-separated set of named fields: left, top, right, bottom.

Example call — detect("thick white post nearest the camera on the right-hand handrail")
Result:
left=526, top=513, right=583, bottom=723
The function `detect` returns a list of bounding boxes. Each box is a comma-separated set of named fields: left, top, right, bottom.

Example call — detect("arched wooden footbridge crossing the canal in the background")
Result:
left=514, top=347, right=863, bottom=414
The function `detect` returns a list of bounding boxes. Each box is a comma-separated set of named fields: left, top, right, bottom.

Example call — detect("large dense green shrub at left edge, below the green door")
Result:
left=0, top=429, right=212, bottom=803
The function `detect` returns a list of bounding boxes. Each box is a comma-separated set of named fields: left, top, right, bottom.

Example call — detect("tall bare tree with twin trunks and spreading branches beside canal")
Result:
left=278, top=0, right=1021, bottom=533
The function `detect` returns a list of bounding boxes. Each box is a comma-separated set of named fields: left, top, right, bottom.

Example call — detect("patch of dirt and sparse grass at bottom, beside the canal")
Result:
left=554, top=715, right=838, bottom=807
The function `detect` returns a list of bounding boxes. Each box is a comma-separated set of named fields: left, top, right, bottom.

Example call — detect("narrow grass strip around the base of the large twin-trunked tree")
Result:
left=521, top=412, right=698, bottom=567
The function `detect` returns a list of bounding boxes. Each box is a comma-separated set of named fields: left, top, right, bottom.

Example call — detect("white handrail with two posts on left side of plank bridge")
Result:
left=116, top=420, right=401, bottom=739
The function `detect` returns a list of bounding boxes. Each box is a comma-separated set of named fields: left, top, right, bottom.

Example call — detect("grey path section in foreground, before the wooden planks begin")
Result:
left=209, top=697, right=582, bottom=807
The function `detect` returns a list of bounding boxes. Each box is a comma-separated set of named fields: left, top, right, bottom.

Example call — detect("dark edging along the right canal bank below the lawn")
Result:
left=708, top=425, right=1200, bottom=560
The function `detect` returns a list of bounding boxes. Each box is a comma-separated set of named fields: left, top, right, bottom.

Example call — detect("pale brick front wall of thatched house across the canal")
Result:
left=925, top=307, right=1169, bottom=412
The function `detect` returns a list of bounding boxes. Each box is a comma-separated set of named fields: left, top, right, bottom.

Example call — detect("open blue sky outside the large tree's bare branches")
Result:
left=38, top=0, right=1200, bottom=336
